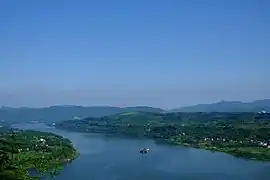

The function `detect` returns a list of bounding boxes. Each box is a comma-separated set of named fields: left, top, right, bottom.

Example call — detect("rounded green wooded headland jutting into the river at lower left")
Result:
left=0, top=130, right=77, bottom=180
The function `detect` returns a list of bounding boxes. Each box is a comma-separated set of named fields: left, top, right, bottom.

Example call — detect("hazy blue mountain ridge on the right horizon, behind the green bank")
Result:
left=170, top=99, right=270, bottom=112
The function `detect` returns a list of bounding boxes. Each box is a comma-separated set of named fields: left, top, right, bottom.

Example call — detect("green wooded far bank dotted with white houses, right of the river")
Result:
left=56, top=112, right=270, bottom=160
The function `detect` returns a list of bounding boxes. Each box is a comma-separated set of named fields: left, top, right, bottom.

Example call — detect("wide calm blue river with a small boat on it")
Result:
left=14, top=123, right=270, bottom=180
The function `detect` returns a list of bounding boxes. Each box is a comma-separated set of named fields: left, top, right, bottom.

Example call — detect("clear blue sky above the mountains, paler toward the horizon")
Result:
left=0, top=0, right=270, bottom=108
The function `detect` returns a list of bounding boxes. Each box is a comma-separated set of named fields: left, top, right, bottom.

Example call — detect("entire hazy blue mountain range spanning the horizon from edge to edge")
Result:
left=0, top=99, right=270, bottom=123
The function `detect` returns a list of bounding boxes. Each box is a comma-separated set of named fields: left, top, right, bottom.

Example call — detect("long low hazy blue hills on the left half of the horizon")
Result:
left=0, top=105, right=164, bottom=123
